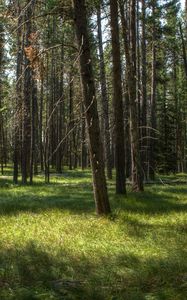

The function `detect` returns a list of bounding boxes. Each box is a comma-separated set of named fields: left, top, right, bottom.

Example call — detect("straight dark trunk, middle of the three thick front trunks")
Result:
left=110, top=0, right=126, bottom=194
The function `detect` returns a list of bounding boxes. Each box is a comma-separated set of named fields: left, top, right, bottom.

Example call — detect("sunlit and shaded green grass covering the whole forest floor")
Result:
left=0, top=171, right=187, bottom=300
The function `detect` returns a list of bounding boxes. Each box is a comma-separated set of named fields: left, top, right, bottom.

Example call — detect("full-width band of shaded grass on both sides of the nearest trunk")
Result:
left=0, top=179, right=187, bottom=215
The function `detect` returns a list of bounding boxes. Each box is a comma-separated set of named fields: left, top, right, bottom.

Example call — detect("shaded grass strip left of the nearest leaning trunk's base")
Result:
left=0, top=185, right=95, bottom=215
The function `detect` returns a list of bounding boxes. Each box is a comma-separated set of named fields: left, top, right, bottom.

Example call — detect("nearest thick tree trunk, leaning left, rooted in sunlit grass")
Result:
left=73, top=0, right=110, bottom=215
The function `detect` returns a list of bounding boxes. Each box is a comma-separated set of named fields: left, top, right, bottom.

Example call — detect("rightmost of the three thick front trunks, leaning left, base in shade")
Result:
left=120, top=0, right=143, bottom=191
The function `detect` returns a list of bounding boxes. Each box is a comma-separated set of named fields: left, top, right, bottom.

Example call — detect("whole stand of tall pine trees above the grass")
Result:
left=0, top=0, right=187, bottom=214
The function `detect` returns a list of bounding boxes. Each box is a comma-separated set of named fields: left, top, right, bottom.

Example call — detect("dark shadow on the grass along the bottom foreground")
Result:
left=0, top=242, right=187, bottom=300
